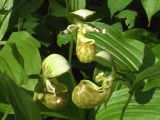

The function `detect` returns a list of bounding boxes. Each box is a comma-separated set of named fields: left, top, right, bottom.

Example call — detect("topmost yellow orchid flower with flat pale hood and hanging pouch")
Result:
left=63, top=9, right=105, bottom=63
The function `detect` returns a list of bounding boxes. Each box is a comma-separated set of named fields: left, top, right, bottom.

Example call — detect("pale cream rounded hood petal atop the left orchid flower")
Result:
left=42, top=54, right=70, bottom=78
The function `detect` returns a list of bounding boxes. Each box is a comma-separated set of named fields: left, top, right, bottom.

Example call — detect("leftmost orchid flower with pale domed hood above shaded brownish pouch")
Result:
left=34, top=54, right=70, bottom=110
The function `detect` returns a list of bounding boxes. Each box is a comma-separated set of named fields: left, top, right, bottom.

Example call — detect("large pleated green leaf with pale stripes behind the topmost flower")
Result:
left=87, top=22, right=144, bottom=71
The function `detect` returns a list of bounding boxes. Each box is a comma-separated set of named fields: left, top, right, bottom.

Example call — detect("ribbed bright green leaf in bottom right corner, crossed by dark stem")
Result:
left=95, top=89, right=160, bottom=120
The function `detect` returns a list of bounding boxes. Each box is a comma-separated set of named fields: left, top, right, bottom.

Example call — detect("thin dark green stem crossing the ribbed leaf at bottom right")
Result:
left=120, top=90, right=133, bottom=120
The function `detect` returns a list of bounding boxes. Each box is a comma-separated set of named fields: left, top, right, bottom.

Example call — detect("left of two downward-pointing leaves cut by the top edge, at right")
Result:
left=108, top=0, right=132, bottom=17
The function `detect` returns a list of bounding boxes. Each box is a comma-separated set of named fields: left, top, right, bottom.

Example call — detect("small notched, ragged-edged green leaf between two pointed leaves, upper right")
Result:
left=116, top=10, right=137, bottom=29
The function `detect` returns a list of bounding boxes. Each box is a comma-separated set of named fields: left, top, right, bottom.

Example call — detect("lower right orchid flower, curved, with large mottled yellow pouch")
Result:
left=72, top=51, right=116, bottom=109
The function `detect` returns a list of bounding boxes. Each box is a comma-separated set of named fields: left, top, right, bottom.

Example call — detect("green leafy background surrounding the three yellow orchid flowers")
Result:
left=0, top=0, right=160, bottom=120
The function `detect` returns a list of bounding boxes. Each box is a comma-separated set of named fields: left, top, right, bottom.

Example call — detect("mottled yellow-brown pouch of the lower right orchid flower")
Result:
left=72, top=80, right=110, bottom=109
